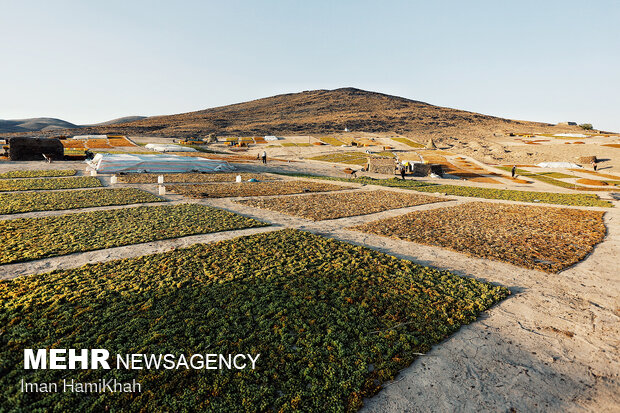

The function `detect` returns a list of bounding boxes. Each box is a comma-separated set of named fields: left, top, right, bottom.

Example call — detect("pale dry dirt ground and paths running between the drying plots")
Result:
left=0, top=159, right=620, bottom=412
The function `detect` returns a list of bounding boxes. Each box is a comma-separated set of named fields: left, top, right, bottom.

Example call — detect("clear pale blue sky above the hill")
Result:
left=0, top=0, right=620, bottom=131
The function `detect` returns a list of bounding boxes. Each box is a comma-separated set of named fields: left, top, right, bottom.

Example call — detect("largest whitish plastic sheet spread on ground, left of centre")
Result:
left=86, top=153, right=235, bottom=174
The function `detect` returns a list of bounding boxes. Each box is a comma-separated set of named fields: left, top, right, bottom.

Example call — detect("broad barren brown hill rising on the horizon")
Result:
left=3, top=88, right=588, bottom=138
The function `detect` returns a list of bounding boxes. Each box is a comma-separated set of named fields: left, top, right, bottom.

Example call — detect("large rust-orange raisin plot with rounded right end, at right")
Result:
left=354, top=202, right=606, bottom=272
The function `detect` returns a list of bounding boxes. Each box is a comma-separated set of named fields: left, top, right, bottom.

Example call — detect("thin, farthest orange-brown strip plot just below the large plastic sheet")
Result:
left=166, top=181, right=350, bottom=198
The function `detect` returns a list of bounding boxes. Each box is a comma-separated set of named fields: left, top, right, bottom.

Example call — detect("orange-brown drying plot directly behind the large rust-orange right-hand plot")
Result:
left=237, top=191, right=447, bottom=221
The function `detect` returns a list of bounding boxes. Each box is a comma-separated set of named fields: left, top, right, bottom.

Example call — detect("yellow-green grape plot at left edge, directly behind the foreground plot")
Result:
left=0, top=204, right=267, bottom=264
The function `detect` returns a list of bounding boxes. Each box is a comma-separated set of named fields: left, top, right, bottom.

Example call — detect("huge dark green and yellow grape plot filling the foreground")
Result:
left=0, top=229, right=509, bottom=413
